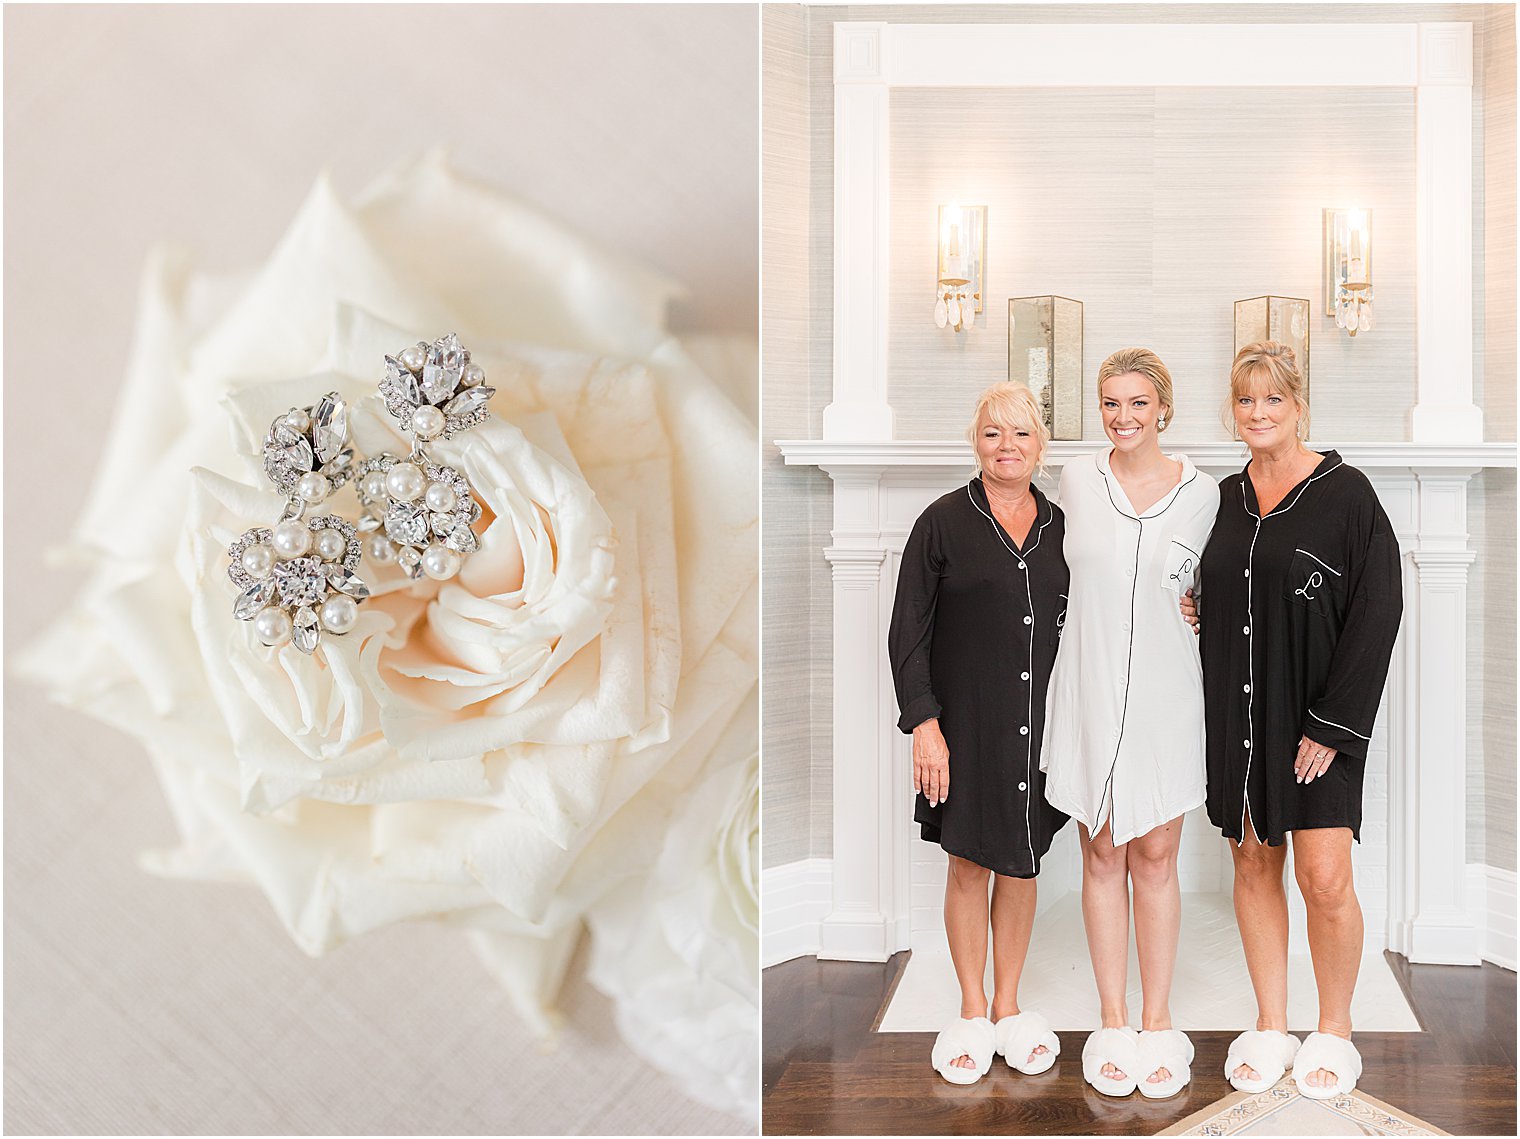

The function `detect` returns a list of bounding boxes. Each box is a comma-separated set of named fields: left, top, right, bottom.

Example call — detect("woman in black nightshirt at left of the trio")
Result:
left=888, top=383, right=1067, bottom=1084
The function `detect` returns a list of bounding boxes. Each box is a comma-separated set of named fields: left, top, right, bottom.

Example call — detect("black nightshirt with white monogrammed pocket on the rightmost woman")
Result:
left=1199, top=450, right=1403, bottom=846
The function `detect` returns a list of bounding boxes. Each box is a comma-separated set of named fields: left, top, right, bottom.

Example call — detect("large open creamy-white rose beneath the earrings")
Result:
left=24, top=155, right=757, bottom=1113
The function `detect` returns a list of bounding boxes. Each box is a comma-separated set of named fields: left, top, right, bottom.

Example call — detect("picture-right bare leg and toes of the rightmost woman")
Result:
left=1294, top=827, right=1362, bottom=1087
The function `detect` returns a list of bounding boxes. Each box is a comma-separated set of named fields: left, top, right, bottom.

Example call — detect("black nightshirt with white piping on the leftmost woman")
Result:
left=888, top=479, right=1070, bottom=877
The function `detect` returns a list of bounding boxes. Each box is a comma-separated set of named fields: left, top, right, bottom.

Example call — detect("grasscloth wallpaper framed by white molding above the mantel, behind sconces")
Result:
left=888, top=87, right=1415, bottom=443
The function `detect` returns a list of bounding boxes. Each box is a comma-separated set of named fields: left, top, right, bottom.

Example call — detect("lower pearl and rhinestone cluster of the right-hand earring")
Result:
left=356, top=455, right=480, bottom=581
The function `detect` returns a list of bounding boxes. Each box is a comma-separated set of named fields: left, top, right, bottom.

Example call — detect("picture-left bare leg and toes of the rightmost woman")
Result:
left=1230, top=820, right=1287, bottom=1080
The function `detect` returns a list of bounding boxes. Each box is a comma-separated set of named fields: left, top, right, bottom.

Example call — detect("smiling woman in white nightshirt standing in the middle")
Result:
left=1041, top=348, right=1219, bottom=1099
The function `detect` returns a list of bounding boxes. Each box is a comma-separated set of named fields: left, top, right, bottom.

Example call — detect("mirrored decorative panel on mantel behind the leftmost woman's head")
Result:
left=1008, top=297, right=1082, bottom=439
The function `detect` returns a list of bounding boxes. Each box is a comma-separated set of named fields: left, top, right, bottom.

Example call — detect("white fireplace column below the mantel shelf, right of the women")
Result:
left=1395, top=468, right=1480, bottom=964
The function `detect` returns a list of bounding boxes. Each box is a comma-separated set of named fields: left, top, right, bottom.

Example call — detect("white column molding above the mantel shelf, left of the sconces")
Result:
left=824, top=23, right=892, bottom=439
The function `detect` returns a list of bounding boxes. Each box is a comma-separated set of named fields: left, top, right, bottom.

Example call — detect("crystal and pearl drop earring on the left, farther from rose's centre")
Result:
left=226, top=392, right=369, bottom=655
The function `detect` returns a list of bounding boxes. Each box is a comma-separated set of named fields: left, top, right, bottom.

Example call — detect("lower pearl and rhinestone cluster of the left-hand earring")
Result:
left=226, top=514, right=369, bottom=654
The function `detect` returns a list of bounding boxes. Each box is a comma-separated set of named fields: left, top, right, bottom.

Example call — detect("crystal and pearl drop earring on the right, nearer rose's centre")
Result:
left=356, top=333, right=496, bottom=581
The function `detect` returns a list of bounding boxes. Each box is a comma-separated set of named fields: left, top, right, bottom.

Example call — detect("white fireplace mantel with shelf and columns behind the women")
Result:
left=778, top=439, right=1515, bottom=964
